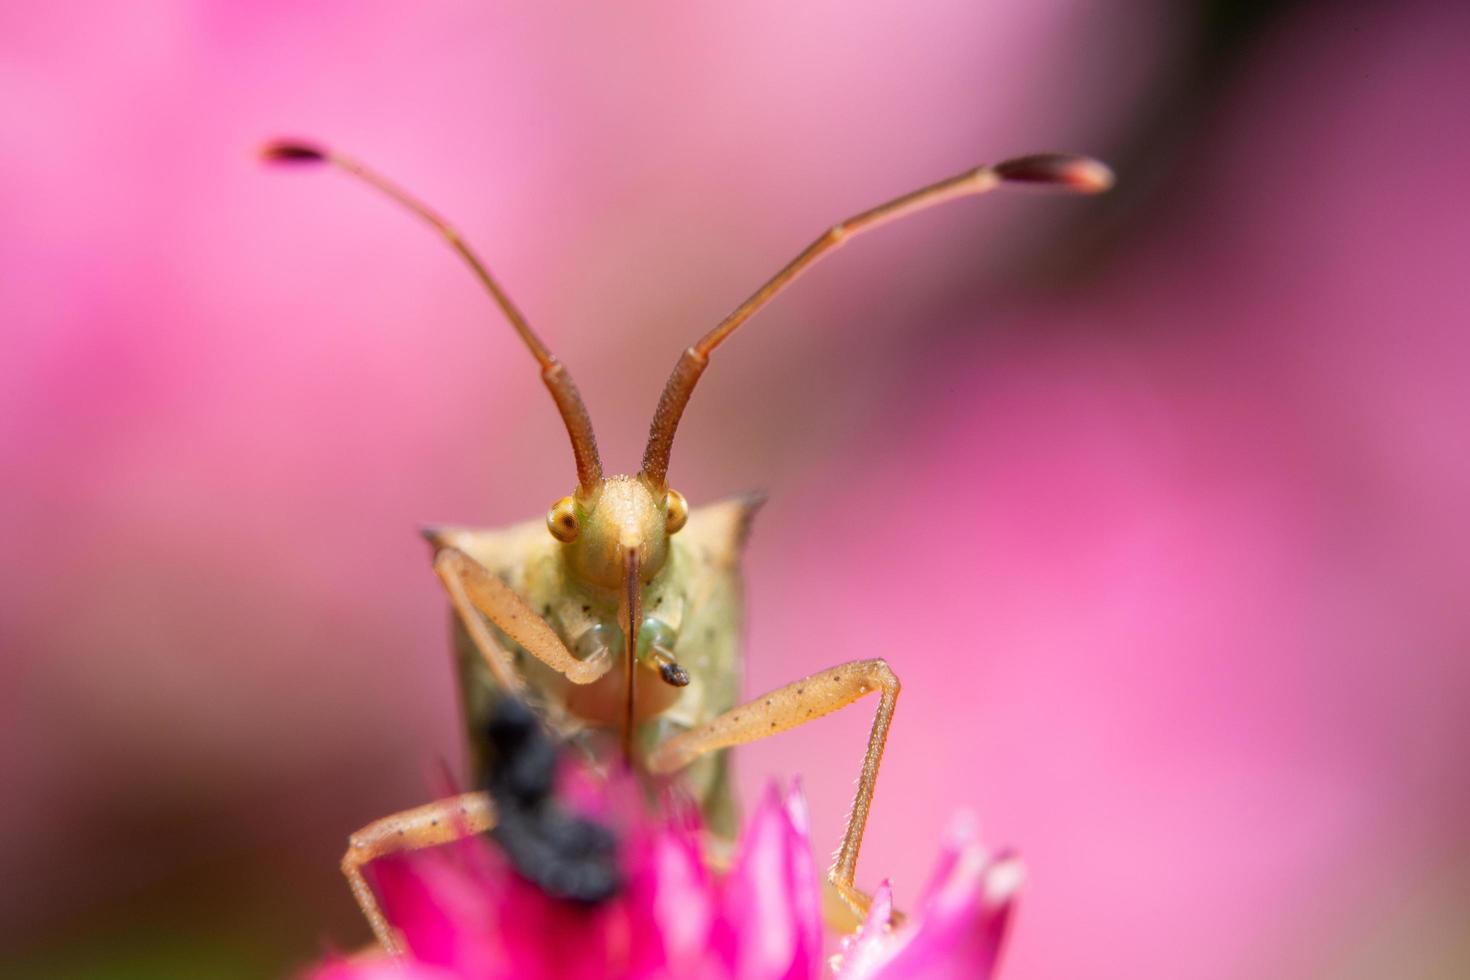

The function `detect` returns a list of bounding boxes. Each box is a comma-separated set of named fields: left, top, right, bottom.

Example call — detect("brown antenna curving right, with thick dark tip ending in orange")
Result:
left=642, top=153, right=1113, bottom=488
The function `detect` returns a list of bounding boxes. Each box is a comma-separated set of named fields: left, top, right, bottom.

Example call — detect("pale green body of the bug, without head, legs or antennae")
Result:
left=432, top=497, right=760, bottom=837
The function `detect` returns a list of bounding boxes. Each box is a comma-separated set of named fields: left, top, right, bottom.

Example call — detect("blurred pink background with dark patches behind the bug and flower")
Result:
left=0, top=0, right=1470, bottom=980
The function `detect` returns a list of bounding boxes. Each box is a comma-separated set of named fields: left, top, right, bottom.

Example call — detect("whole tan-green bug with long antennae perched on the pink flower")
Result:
left=263, top=141, right=1113, bottom=951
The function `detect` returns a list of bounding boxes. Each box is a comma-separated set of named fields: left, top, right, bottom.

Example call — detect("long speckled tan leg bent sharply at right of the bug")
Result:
left=648, top=660, right=900, bottom=915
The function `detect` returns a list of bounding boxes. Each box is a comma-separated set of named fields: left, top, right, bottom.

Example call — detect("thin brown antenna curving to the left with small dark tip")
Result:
left=260, top=140, right=603, bottom=491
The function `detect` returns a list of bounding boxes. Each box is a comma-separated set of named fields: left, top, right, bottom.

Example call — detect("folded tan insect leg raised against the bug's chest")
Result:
left=434, top=548, right=613, bottom=693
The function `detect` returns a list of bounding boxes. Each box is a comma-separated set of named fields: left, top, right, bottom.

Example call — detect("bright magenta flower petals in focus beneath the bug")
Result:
left=312, top=789, right=1020, bottom=980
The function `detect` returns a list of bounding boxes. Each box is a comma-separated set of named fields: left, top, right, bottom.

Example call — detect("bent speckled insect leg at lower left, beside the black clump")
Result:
left=343, top=793, right=495, bottom=955
